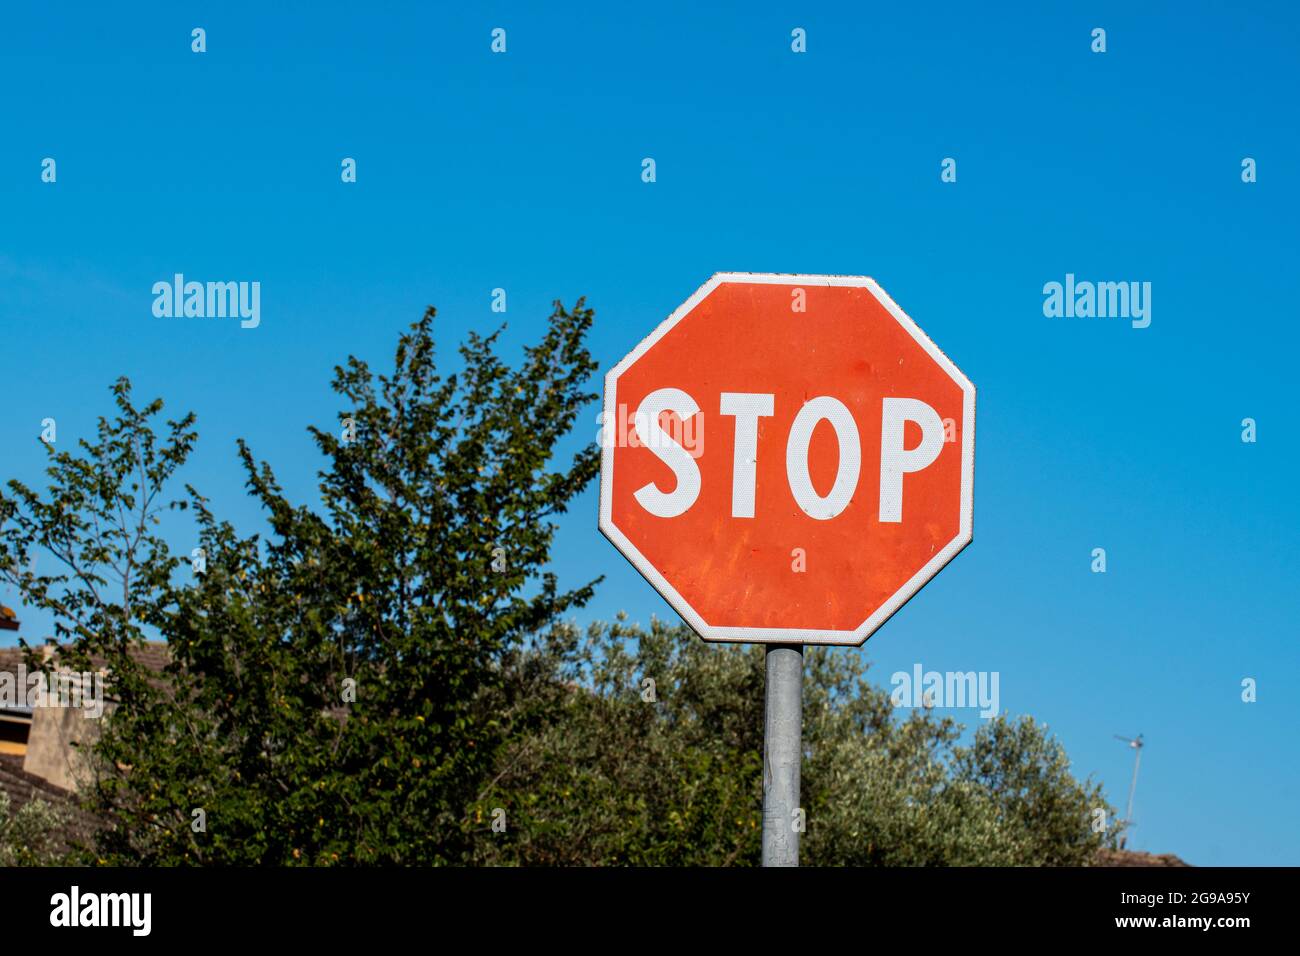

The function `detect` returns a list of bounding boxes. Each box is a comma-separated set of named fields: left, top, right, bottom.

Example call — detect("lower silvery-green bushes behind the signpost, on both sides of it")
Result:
left=477, top=620, right=1114, bottom=866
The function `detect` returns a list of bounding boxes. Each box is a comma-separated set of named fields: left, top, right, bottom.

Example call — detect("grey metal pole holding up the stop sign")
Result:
left=763, top=644, right=803, bottom=866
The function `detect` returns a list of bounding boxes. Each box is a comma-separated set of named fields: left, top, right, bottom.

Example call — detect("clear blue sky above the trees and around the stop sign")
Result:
left=0, top=3, right=1300, bottom=865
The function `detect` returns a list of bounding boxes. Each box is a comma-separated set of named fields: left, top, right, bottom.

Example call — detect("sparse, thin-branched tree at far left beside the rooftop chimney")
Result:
left=0, top=378, right=198, bottom=858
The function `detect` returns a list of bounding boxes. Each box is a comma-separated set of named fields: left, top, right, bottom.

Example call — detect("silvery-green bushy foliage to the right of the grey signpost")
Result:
left=803, top=648, right=1118, bottom=866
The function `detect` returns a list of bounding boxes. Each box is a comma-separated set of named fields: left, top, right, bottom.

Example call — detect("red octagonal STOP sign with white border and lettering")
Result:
left=601, top=273, right=975, bottom=644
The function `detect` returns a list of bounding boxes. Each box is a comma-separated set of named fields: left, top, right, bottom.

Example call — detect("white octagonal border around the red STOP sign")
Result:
left=599, top=272, right=975, bottom=645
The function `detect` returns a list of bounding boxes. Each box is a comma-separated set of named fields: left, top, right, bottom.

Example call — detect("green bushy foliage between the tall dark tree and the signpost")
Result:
left=477, top=613, right=763, bottom=866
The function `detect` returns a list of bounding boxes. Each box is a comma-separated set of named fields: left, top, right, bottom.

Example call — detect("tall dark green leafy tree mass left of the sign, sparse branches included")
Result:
left=0, top=300, right=598, bottom=864
